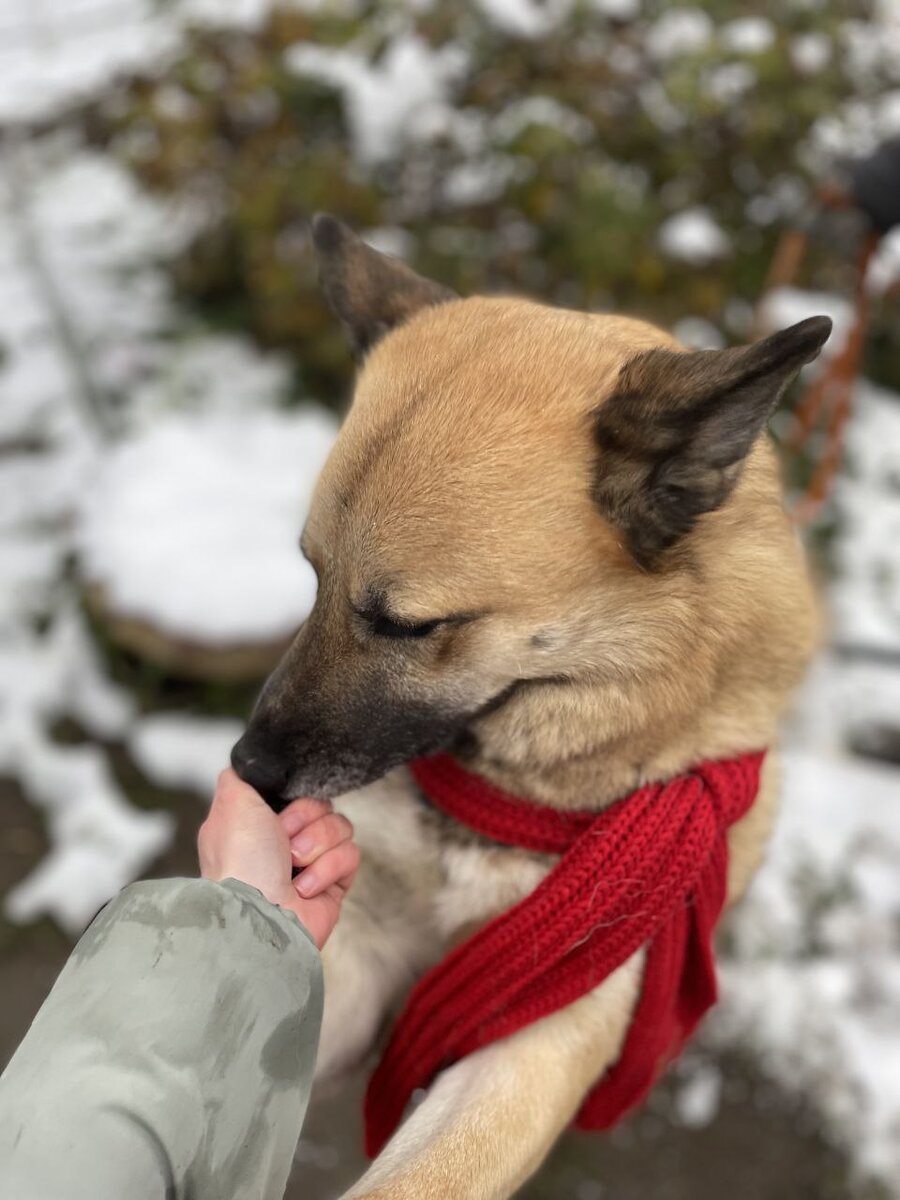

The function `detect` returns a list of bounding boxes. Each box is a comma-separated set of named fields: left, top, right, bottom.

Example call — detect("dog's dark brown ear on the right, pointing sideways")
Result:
left=594, top=317, right=832, bottom=570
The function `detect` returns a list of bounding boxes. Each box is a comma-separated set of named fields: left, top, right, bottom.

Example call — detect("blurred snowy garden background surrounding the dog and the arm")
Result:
left=0, top=0, right=900, bottom=1200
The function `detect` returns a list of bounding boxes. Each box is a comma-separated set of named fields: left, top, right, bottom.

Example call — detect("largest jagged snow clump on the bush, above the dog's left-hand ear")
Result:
left=286, top=31, right=466, bottom=167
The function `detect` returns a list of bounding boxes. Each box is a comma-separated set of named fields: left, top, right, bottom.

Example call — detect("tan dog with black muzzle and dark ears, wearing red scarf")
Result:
left=234, top=217, right=830, bottom=1200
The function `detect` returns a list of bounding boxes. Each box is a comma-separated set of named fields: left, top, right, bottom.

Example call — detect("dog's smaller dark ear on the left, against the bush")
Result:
left=312, top=212, right=456, bottom=356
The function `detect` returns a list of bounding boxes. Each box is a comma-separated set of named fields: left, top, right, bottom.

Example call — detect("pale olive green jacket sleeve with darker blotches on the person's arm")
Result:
left=0, top=880, right=323, bottom=1200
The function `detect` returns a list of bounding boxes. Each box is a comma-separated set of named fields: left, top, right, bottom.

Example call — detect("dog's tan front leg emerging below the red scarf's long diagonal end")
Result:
left=343, top=954, right=642, bottom=1200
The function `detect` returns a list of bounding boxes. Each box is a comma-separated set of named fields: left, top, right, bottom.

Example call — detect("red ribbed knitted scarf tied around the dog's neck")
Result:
left=365, top=754, right=763, bottom=1154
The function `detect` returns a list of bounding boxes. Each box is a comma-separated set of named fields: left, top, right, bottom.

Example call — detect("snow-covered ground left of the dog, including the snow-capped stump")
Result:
left=0, top=138, right=335, bottom=932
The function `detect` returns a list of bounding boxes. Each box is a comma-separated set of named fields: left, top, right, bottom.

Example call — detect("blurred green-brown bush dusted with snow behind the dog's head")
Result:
left=90, top=0, right=900, bottom=395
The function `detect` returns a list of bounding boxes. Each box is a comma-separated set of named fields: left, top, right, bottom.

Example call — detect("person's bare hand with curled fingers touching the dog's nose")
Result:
left=197, top=768, right=359, bottom=949
